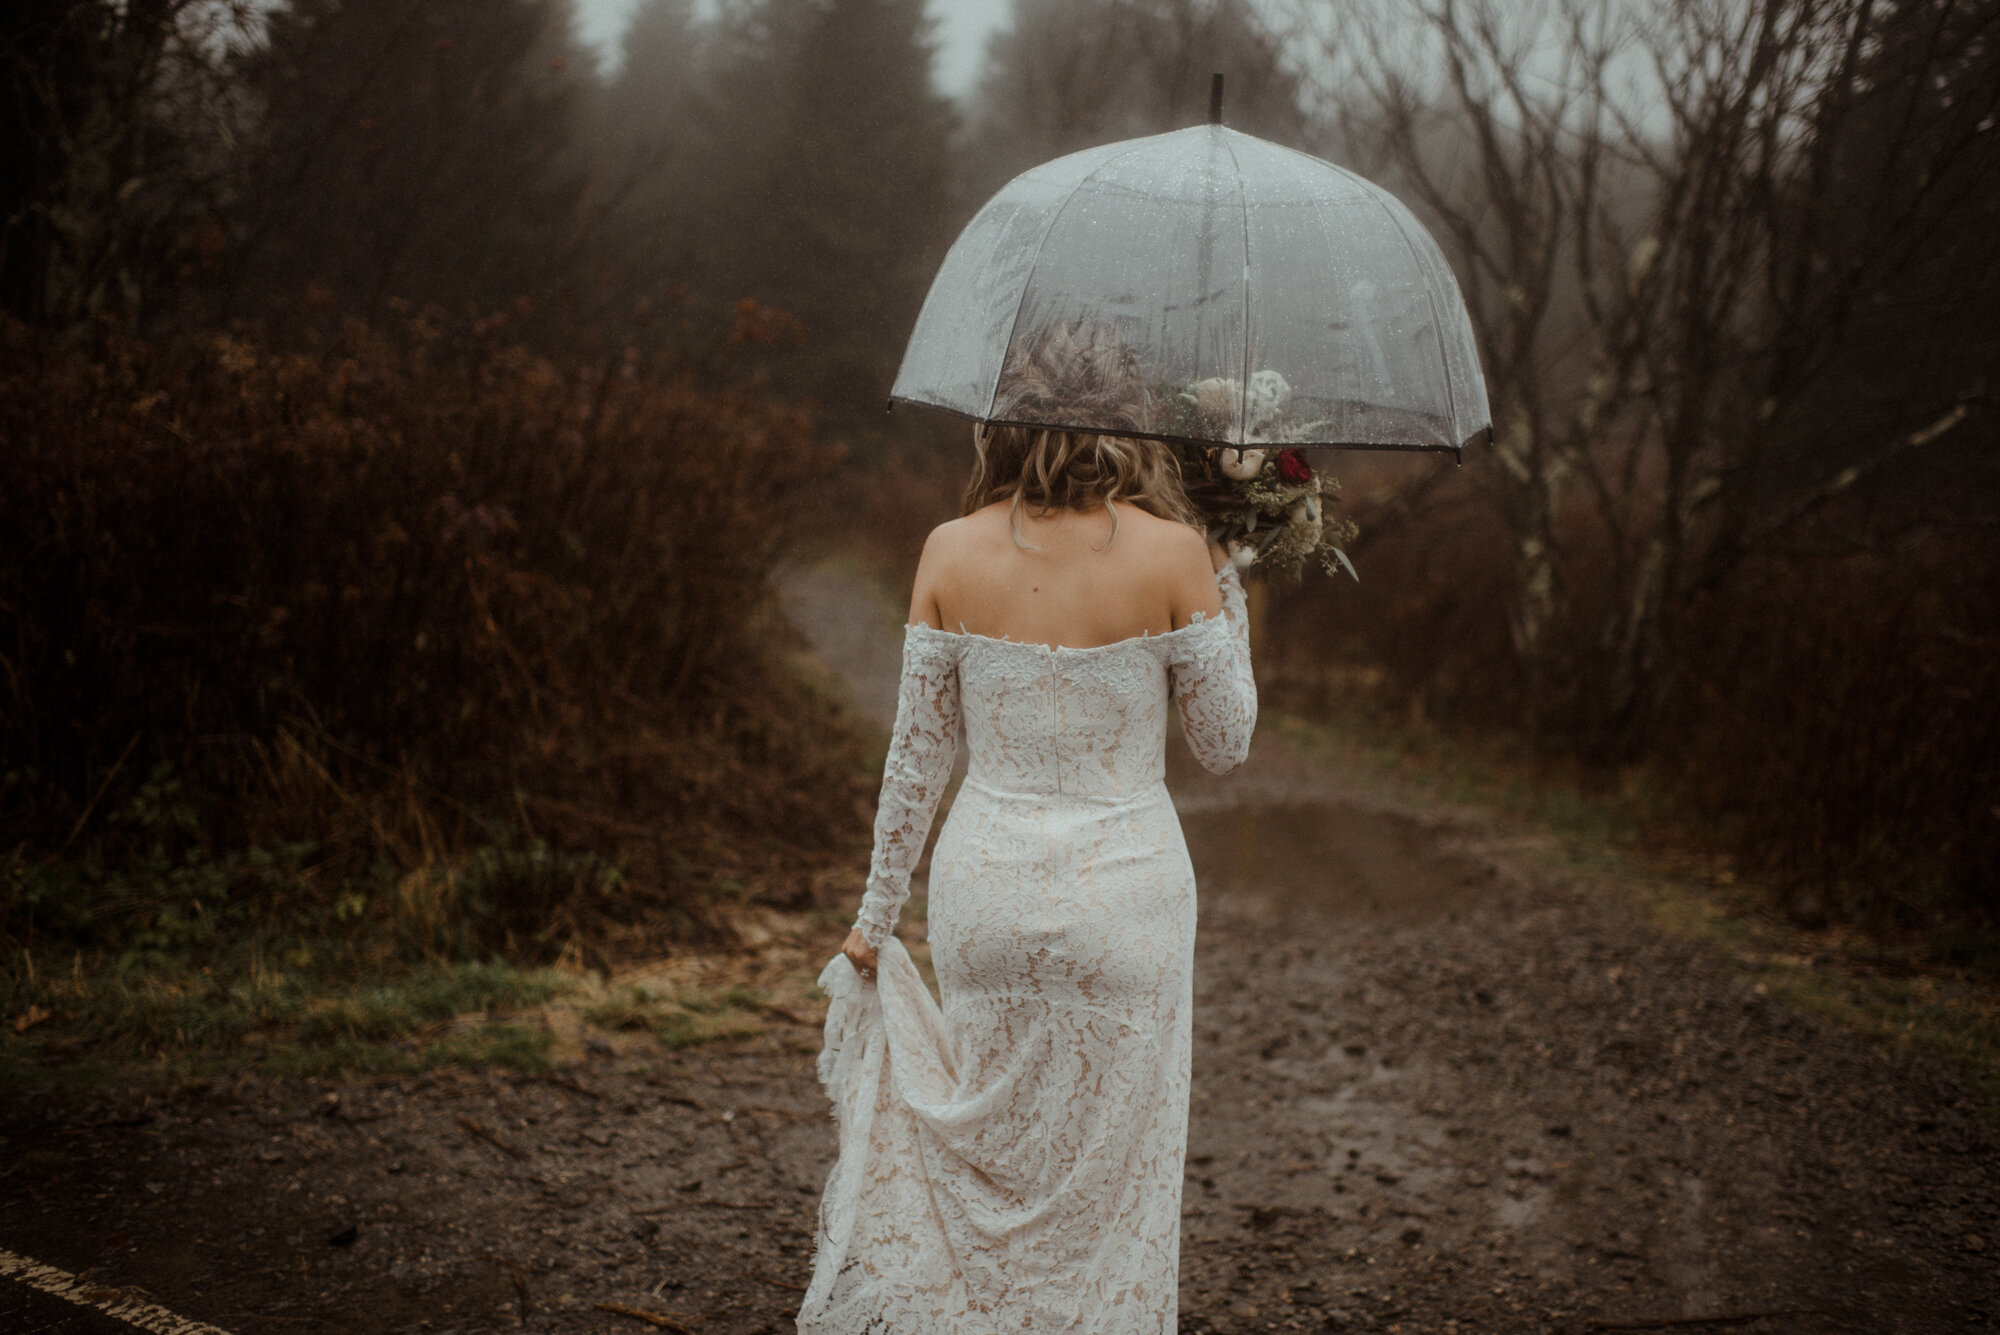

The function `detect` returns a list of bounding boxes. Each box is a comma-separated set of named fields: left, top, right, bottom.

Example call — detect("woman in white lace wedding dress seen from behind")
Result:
left=798, top=328, right=1256, bottom=1335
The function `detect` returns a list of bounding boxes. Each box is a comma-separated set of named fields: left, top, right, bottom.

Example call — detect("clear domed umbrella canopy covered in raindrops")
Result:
left=890, top=124, right=1490, bottom=452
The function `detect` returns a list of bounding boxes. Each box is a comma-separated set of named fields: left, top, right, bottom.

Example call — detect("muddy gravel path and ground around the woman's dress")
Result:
left=0, top=576, right=2000, bottom=1335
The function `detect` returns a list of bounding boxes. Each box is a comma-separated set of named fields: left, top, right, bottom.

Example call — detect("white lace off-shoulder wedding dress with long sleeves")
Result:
left=798, top=566, right=1256, bottom=1335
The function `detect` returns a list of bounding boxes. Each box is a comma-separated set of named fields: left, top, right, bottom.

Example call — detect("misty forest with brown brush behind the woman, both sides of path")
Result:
left=0, top=0, right=2000, bottom=1087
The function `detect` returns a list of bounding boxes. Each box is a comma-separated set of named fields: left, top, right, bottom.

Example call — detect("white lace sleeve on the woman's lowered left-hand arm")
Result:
left=854, top=626, right=958, bottom=949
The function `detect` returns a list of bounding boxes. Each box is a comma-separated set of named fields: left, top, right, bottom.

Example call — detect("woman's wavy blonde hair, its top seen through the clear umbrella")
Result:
left=960, top=320, right=1202, bottom=548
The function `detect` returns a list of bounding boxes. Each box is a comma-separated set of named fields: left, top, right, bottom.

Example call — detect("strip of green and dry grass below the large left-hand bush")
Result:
left=0, top=771, right=800, bottom=1093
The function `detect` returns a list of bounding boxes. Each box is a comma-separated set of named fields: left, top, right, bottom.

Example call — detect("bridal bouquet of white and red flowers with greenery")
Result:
left=1160, top=370, right=1360, bottom=580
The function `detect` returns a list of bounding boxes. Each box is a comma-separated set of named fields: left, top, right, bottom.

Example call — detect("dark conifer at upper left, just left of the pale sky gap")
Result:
left=238, top=0, right=590, bottom=312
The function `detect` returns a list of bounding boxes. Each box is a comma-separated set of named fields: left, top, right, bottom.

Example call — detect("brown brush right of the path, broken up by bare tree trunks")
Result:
left=1258, top=458, right=2000, bottom=939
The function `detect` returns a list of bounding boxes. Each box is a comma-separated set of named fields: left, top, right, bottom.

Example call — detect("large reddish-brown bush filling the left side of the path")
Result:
left=0, top=316, right=862, bottom=959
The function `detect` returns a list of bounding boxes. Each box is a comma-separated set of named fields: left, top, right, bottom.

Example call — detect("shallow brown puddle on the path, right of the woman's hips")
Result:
left=1180, top=801, right=1492, bottom=923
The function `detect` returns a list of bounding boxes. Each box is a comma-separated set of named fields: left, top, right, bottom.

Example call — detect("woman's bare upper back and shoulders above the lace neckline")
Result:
left=910, top=502, right=1222, bottom=648
